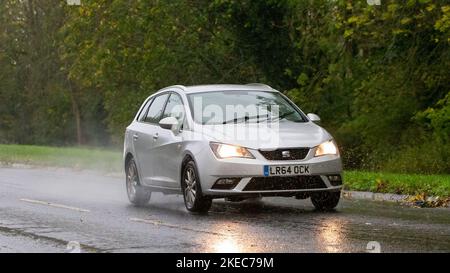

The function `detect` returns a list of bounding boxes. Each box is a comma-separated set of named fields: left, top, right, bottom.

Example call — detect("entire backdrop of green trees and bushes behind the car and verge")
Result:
left=0, top=0, right=450, bottom=173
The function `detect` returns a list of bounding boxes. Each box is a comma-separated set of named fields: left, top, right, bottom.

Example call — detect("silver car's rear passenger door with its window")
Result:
left=133, top=93, right=169, bottom=186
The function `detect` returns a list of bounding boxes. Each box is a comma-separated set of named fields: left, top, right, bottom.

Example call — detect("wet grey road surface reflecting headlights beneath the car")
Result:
left=0, top=167, right=450, bottom=252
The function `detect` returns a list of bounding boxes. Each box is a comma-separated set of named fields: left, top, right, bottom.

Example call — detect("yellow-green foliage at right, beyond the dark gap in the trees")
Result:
left=288, top=1, right=450, bottom=173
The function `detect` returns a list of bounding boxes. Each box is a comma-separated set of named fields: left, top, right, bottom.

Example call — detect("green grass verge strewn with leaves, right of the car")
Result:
left=344, top=171, right=450, bottom=198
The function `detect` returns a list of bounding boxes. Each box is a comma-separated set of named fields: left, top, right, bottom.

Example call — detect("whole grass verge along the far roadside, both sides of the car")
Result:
left=0, top=145, right=450, bottom=198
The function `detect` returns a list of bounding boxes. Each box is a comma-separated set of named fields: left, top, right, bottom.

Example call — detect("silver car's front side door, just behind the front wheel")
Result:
left=152, top=92, right=185, bottom=188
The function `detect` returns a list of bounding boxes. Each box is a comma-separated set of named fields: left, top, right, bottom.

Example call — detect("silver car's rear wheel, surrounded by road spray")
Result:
left=126, top=158, right=152, bottom=207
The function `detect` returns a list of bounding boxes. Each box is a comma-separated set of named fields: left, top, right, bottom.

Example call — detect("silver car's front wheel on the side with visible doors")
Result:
left=181, top=160, right=212, bottom=213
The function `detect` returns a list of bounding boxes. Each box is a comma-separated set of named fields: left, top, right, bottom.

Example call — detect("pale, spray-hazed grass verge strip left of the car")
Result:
left=0, top=145, right=122, bottom=172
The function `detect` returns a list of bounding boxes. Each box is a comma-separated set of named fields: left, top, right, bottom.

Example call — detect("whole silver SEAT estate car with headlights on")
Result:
left=124, top=84, right=342, bottom=212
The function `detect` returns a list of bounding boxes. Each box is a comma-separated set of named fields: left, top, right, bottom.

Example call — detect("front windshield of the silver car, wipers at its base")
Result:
left=188, top=91, right=307, bottom=124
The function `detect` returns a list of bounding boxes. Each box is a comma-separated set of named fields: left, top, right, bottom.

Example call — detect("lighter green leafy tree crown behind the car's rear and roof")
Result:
left=61, top=1, right=264, bottom=142
